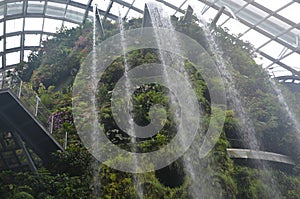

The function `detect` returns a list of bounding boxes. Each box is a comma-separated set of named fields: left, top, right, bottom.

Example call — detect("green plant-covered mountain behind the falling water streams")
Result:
left=0, top=18, right=300, bottom=199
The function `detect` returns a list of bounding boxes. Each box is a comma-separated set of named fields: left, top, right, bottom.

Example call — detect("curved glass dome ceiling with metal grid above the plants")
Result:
left=0, top=0, right=300, bottom=76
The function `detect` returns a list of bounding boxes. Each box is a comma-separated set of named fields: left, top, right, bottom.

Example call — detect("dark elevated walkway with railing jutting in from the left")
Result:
left=0, top=73, right=63, bottom=170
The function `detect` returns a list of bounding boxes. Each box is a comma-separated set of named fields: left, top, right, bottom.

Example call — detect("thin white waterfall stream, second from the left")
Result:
left=119, top=13, right=143, bottom=199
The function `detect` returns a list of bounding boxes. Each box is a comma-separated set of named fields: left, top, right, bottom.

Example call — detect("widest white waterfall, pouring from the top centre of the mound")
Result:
left=147, top=3, right=220, bottom=198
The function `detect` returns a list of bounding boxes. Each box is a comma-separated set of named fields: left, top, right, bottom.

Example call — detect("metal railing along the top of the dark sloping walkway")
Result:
left=0, top=72, right=54, bottom=134
